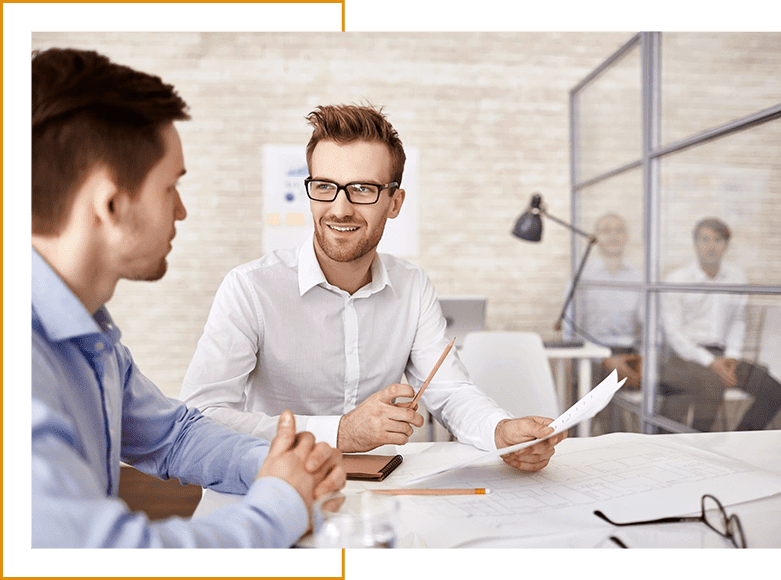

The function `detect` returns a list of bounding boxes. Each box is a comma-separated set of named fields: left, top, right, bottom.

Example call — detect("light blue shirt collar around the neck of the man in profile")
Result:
left=30, top=247, right=121, bottom=342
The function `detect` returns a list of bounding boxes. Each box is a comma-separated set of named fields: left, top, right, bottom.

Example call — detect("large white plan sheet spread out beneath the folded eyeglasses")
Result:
left=386, top=433, right=781, bottom=548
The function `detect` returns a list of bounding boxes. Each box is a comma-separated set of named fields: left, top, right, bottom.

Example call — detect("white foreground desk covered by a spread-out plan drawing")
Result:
left=193, top=430, right=781, bottom=548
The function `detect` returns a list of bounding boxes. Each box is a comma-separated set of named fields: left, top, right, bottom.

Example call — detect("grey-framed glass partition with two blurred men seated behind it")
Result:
left=569, top=32, right=781, bottom=433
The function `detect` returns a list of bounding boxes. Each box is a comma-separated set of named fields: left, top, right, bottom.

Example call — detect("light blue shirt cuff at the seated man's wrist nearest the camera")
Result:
left=244, top=477, right=309, bottom=548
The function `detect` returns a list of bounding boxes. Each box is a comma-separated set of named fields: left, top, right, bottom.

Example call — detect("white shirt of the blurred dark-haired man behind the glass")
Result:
left=662, top=261, right=746, bottom=366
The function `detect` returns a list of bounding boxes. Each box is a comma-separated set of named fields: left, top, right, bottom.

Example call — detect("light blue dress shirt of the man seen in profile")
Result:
left=30, top=249, right=308, bottom=548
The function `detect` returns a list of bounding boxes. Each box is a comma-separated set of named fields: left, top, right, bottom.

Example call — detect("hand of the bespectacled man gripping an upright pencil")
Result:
left=336, top=383, right=423, bottom=453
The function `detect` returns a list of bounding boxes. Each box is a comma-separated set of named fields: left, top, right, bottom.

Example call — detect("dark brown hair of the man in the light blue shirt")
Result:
left=31, top=48, right=190, bottom=235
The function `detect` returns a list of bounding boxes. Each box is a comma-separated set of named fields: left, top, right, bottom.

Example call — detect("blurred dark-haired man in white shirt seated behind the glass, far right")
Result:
left=660, top=218, right=781, bottom=431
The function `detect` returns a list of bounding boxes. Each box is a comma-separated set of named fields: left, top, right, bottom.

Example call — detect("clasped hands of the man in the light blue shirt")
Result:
left=258, top=411, right=347, bottom=523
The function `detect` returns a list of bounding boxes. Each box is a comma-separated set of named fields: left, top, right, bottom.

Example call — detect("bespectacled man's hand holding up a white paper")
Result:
left=494, top=416, right=567, bottom=471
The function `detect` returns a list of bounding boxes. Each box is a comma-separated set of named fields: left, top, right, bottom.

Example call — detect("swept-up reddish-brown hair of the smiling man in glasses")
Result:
left=306, top=105, right=407, bottom=185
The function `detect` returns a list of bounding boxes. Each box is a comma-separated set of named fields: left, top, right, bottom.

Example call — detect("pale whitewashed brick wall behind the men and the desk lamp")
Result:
left=32, top=31, right=781, bottom=429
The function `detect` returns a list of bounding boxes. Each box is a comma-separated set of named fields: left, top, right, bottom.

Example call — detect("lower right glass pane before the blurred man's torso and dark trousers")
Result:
left=657, top=291, right=781, bottom=431
